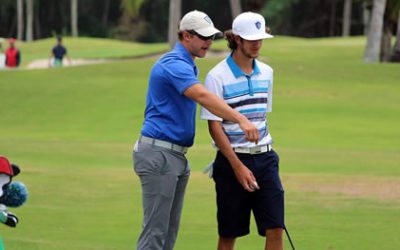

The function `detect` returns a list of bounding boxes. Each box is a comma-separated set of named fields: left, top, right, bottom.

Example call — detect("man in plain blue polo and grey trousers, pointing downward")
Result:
left=133, top=11, right=259, bottom=250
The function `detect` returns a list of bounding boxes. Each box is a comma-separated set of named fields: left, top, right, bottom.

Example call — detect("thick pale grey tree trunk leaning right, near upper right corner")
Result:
left=364, top=0, right=386, bottom=63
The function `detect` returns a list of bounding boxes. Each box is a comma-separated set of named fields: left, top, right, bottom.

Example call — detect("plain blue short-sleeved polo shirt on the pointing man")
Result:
left=141, top=42, right=200, bottom=147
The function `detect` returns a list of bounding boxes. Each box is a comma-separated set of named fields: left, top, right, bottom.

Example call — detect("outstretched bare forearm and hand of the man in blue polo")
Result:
left=183, top=83, right=259, bottom=143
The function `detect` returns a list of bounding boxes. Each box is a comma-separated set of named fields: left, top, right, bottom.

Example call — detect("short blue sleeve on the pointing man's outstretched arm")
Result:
left=164, top=60, right=200, bottom=95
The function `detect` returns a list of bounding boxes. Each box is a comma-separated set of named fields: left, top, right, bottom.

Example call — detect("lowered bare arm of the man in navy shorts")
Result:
left=208, top=120, right=259, bottom=192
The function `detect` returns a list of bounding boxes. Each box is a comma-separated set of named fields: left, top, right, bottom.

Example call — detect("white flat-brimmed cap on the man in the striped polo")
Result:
left=232, top=12, right=273, bottom=41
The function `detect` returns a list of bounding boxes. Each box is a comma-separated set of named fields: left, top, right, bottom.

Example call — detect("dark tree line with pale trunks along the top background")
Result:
left=0, top=0, right=400, bottom=62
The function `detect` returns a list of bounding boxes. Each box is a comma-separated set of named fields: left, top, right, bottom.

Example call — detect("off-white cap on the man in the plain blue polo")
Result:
left=179, top=10, right=221, bottom=37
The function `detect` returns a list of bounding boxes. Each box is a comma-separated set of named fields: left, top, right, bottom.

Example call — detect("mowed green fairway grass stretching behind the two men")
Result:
left=0, top=37, right=400, bottom=250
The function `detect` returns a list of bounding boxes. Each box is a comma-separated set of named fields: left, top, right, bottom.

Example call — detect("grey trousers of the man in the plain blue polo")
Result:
left=133, top=142, right=190, bottom=250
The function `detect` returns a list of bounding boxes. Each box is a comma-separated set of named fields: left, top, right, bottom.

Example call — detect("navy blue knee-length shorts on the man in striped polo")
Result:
left=213, top=150, right=285, bottom=238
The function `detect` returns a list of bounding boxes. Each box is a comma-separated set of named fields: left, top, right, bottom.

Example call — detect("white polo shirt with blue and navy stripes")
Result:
left=200, top=55, right=273, bottom=147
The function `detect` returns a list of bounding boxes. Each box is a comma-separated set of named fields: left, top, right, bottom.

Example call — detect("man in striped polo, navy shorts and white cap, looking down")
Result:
left=201, top=12, right=284, bottom=250
